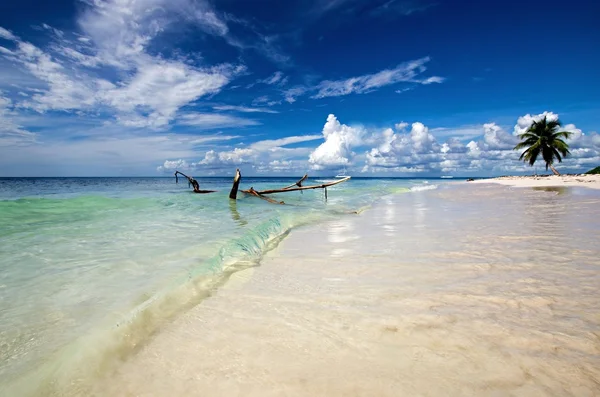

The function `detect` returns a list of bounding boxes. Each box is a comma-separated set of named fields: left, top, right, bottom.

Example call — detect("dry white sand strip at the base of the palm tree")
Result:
left=469, top=175, right=600, bottom=189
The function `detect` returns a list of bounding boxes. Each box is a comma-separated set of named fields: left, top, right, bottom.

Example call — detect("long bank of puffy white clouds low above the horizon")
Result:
left=159, top=110, right=600, bottom=175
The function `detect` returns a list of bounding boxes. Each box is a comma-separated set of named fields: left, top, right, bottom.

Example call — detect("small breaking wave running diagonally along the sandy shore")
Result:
left=6, top=214, right=319, bottom=396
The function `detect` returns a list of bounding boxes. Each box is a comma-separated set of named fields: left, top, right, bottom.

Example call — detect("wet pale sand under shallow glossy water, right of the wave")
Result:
left=90, top=184, right=600, bottom=396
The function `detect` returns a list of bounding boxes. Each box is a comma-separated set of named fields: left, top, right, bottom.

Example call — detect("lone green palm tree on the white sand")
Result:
left=514, top=116, right=571, bottom=175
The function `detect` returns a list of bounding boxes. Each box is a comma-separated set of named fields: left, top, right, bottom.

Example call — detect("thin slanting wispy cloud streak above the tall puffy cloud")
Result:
left=313, top=57, right=444, bottom=98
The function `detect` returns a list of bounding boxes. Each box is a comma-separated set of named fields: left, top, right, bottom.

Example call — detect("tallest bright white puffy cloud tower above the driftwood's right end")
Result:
left=308, top=114, right=365, bottom=170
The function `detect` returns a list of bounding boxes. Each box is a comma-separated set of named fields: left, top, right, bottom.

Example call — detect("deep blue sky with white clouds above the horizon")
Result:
left=0, top=0, right=600, bottom=177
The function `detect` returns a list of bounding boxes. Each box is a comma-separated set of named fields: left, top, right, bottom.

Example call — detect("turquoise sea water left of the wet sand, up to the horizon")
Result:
left=0, top=178, right=440, bottom=394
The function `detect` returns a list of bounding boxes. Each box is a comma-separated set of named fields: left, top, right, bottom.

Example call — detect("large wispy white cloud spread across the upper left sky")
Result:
left=0, top=0, right=245, bottom=128
